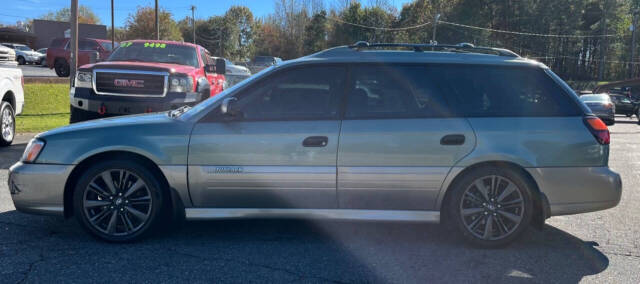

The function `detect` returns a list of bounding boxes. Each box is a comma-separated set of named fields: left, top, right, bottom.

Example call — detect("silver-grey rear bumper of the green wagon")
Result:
left=527, top=167, right=622, bottom=216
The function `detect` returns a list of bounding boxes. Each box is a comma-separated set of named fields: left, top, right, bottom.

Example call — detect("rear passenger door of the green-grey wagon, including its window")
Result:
left=338, top=64, right=475, bottom=210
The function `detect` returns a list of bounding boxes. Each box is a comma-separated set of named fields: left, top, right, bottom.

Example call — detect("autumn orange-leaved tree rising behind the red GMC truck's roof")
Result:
left=125, top=7, right=182, bottom=41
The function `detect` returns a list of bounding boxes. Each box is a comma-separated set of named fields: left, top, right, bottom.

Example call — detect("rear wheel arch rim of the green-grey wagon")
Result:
left=438, top=161, right=550, bottom=229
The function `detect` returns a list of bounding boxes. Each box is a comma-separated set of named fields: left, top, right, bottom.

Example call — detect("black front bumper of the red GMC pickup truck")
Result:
left=69, top=88, right=208, bottom=115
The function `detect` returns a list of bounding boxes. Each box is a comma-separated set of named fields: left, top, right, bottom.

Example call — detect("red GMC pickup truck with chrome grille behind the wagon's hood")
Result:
left=69, top=40, right=226, bottom=123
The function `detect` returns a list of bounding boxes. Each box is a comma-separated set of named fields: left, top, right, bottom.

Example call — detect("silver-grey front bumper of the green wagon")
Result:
left=8, top=162, right=73, bottom=216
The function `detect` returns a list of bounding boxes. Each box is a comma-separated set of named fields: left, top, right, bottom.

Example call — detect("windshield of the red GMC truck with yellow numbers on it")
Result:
left=107, top=42, right=198, bottom=67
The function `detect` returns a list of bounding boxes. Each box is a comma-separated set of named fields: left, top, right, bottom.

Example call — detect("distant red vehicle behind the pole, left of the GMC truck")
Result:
left=47, top=38, right=118, bottom=77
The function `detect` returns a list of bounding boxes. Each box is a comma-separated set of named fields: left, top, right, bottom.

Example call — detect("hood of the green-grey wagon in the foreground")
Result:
left=36, top=112, right=176, bottom=140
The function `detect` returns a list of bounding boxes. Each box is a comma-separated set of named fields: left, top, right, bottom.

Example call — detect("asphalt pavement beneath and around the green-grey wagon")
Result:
left=0, top=117, right=640, bottom=283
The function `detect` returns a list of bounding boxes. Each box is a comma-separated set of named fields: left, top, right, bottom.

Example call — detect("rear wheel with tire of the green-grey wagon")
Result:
left=445, top=166, right=533, bottom=248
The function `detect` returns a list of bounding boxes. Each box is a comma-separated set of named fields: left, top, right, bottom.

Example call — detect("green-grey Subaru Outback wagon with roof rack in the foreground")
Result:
left=9, top=43, right=622, bottom=247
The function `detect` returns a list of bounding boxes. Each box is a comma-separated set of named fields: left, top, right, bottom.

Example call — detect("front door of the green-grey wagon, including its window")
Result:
left=189, top=66, right=346, bottom=208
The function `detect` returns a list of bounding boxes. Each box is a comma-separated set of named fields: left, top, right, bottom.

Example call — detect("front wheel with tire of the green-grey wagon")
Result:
left=73, top=160, right=165, bottom=242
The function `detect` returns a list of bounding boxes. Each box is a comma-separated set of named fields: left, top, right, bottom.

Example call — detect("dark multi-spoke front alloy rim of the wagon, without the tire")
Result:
left=83, top=169, right=153, bottom=237
